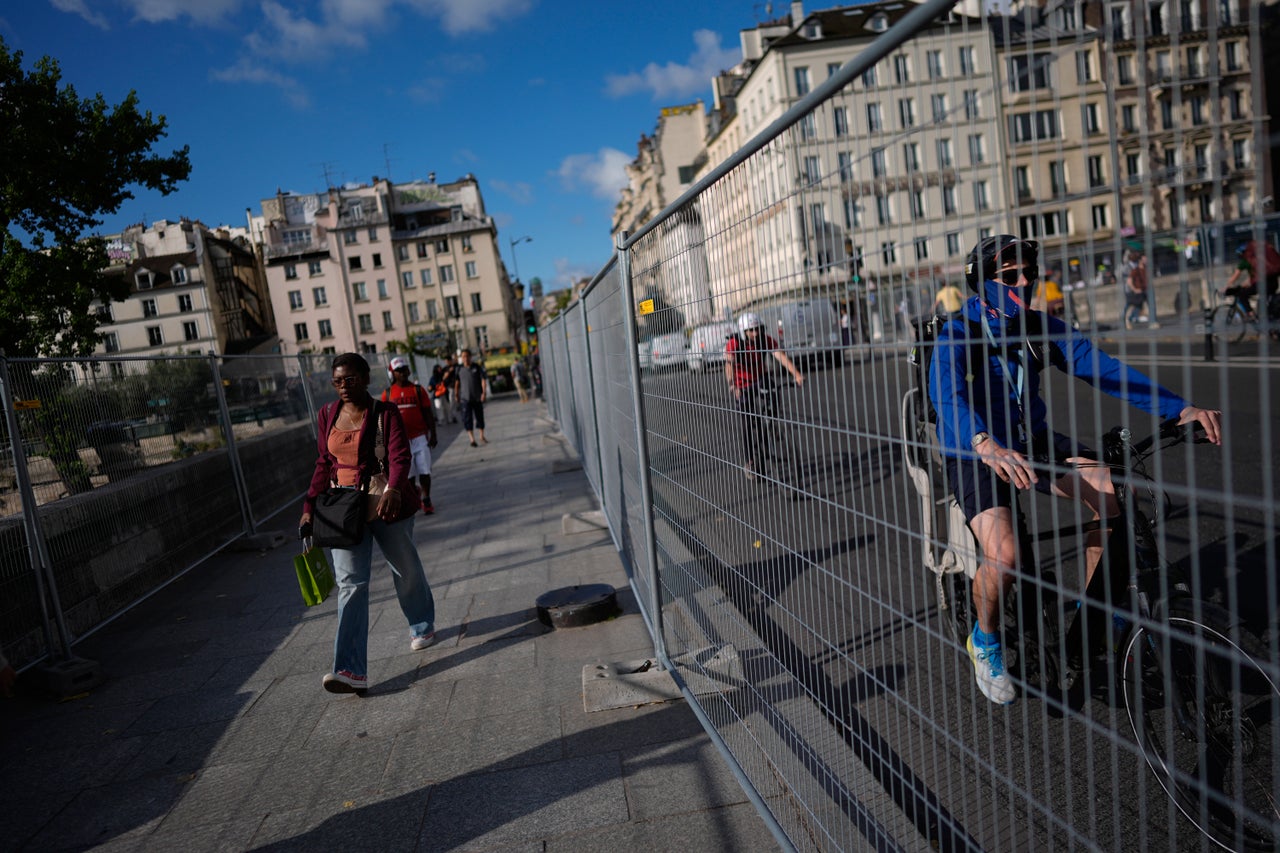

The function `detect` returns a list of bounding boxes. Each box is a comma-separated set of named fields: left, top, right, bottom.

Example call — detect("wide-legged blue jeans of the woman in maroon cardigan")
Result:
left=333, top=516, right=435, bottom=675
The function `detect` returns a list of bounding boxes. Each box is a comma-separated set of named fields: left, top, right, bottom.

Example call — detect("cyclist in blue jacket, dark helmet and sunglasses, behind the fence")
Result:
left=929, top=234, right=1221, bottom=704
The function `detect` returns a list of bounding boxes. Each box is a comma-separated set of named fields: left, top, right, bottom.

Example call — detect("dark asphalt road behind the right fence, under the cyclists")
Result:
left=634, top=339, right=1280, bottom=850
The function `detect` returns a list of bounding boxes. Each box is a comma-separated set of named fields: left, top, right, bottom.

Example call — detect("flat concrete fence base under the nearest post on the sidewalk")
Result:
left=582, top=646, right=742, bottom=713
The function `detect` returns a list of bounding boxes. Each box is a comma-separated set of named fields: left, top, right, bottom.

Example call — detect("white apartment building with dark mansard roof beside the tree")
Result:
left=95, top=218, right=275, bottom=370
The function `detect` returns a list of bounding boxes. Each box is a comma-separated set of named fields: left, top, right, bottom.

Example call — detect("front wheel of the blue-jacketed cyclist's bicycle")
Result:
left=1123, top=599, right=1280, bottom=850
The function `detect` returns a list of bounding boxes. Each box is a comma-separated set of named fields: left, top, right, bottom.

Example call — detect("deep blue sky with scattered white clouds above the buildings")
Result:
left=0, top=0, right=757, bottom=289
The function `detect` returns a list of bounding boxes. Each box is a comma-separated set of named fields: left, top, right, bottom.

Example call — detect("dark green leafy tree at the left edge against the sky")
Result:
left=0, top=40, right=191, bottom=356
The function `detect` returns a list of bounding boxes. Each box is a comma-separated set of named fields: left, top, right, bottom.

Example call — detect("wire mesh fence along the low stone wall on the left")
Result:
left=0, top=356, right=334, bottom=666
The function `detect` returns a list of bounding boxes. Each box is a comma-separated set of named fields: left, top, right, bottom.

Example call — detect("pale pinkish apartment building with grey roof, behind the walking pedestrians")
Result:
left=255, top=174, right=522, bottom=353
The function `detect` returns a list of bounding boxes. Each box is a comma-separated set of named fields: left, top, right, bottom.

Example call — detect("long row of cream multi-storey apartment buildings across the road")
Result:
left=613, top=0, right=1280, bottom=313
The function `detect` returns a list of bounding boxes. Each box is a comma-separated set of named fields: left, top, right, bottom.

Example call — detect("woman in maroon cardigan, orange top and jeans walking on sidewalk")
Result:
left=298, top=352, right=435, bottom=693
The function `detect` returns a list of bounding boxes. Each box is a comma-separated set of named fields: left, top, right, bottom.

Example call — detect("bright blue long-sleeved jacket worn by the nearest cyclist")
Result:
left=929, top=296, right=1190, bottom=459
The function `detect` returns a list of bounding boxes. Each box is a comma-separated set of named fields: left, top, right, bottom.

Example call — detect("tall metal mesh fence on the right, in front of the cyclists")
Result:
left=539, top=3, right=1280, bottom=850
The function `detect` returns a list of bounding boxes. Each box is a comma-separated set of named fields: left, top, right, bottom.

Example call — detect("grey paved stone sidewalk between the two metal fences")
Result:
left=0, top=397, right=776, bottom=853
